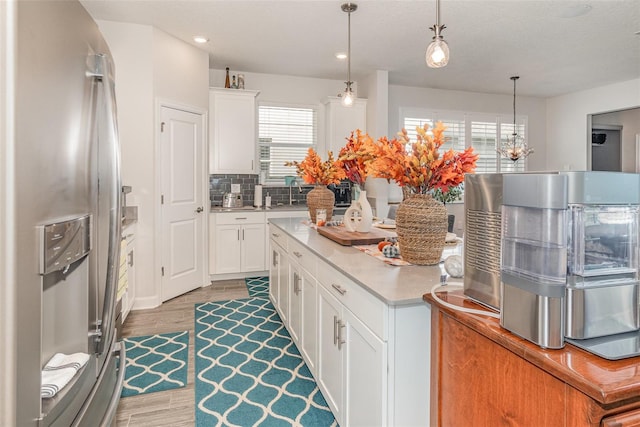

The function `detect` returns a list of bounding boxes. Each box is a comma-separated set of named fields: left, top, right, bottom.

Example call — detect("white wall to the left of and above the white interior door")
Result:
left=98, top=21, right=209, bottom=309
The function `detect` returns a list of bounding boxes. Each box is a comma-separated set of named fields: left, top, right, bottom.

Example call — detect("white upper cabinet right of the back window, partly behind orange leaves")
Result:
left=324, top=97, right=367, bottom=158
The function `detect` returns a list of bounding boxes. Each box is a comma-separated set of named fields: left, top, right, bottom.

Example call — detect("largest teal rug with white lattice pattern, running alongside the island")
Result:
left=195, top=297, right=337, bottom=427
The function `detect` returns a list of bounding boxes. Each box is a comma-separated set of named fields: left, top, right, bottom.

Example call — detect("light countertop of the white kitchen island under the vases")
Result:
left=269, top=218, right=460, bottom=305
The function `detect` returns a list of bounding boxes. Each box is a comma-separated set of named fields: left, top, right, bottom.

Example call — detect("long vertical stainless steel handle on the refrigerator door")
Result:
left=96, top=54, right=122, bottom=354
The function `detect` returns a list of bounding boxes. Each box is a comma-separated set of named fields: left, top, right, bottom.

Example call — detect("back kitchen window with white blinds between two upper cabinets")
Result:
left=258, top=105, right=317, bottom=182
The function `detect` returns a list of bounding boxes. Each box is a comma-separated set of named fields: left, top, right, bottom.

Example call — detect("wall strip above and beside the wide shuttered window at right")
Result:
left=389, top=85, right=547, bottom=171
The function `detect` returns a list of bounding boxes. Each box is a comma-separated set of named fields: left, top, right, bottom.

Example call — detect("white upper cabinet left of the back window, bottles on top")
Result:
left=209, top=88, right=260, bottom=174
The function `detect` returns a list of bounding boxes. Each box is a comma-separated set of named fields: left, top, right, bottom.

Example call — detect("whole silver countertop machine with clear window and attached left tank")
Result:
left=500, top=171, right=640, bottom=358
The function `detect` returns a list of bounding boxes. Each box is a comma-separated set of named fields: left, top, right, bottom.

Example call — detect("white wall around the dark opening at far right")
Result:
left=546, top=78, right=640, bottom=170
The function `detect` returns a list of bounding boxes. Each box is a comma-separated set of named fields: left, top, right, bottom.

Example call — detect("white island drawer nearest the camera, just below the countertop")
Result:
left=317, top=261, right=388, bottom=341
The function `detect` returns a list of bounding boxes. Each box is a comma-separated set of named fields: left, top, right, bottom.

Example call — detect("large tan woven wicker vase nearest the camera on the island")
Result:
left=396, top=194, right=447, bottom=265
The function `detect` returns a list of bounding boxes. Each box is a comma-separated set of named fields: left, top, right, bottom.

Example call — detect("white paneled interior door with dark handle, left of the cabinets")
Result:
left=159, top=106, right=209, bottom=301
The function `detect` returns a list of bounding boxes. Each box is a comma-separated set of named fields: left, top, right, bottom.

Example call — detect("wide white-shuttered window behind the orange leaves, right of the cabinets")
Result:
left=402, top=111, right=526, bottom=173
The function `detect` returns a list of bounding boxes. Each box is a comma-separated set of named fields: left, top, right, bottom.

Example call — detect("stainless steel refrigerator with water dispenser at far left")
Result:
left=7, top=0, right=124, bottom=426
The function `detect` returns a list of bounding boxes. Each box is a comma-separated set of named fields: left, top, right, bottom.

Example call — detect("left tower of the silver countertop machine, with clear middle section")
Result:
left=500, top=174, right=568, bottom=348
